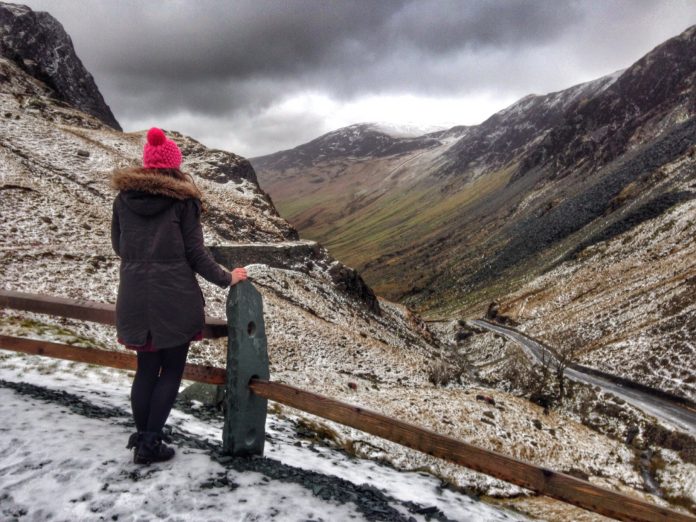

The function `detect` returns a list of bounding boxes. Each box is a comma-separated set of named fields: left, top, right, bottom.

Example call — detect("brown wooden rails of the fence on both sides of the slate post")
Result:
left=0, top=291, right=696, bottom=522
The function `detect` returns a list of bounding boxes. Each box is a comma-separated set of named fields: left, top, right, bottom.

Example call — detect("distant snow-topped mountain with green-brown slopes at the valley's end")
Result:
left=250, top=72, right=620, bottom=300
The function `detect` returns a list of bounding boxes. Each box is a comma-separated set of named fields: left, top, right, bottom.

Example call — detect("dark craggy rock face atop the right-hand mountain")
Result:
left=516, top=26, right=696, bottom=181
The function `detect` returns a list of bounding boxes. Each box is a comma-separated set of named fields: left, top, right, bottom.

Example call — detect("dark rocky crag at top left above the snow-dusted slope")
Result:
left=0, top=2, right=121, bottom=130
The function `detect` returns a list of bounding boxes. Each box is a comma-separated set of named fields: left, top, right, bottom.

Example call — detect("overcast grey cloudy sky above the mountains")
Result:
left=17, top=0, right=696, bottom=157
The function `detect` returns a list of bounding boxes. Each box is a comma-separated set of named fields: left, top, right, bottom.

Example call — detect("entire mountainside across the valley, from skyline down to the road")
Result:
left=252, top=27, right=696, bottom=398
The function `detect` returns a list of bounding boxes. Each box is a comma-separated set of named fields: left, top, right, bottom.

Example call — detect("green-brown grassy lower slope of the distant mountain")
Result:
left=274, top=158, right=528, bottom=313
